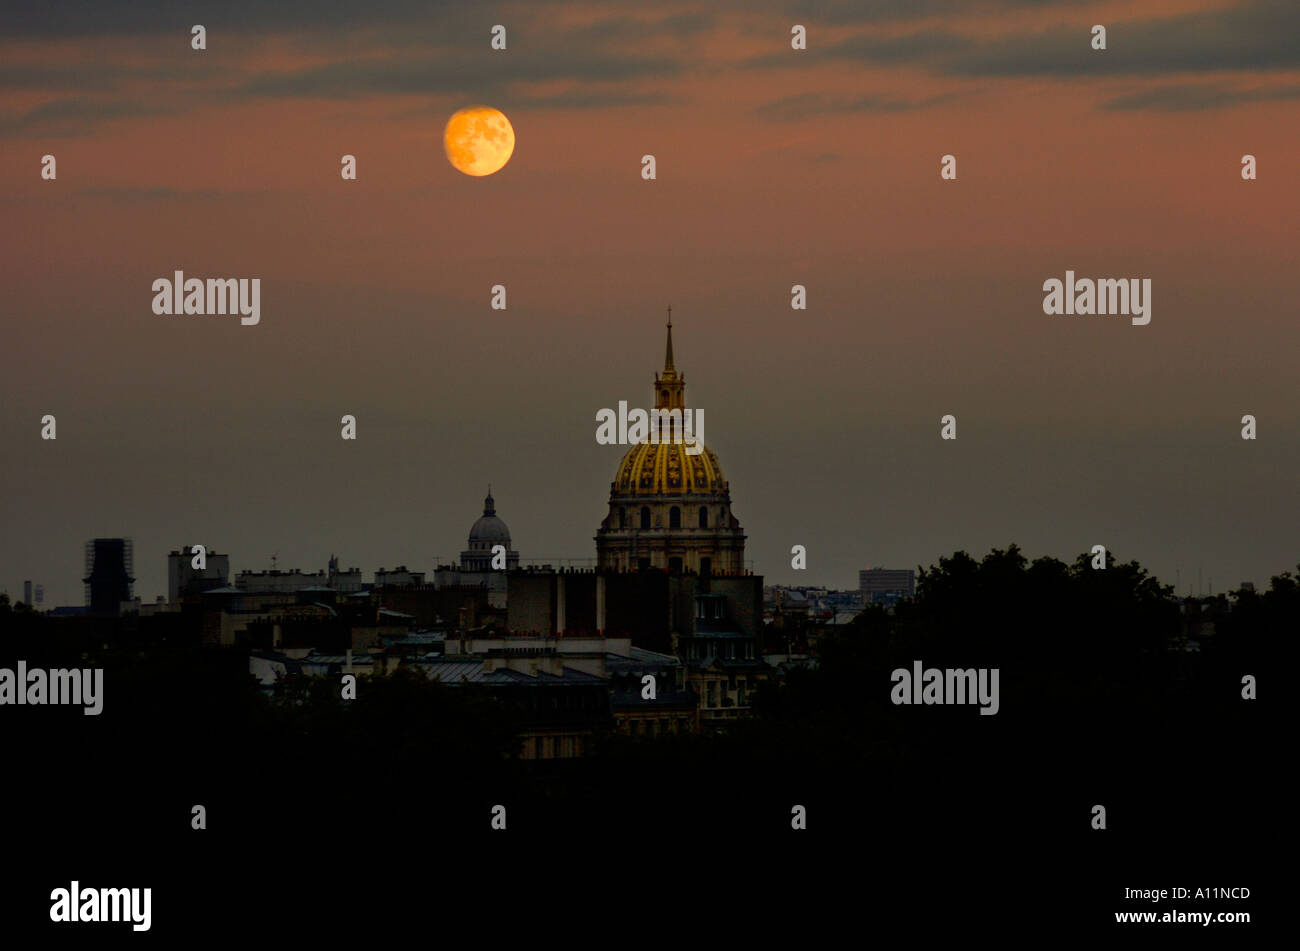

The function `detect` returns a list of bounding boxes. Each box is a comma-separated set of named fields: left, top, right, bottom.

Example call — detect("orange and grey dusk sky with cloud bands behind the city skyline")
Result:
left=0, top=0, right=1300, bottom=607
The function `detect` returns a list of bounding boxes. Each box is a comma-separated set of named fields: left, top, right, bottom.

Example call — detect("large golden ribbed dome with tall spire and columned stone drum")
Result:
left=595, top=309, right=745, bottom=576
